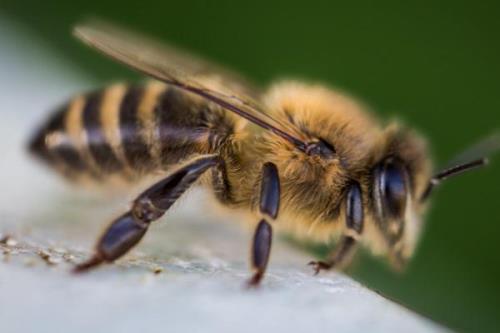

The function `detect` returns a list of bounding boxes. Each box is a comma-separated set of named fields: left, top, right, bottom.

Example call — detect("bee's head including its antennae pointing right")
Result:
left=369, top=126, right=500, bottom=268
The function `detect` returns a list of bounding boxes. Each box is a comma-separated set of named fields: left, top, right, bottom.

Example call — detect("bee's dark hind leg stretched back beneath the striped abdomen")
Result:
left=74, top=155, right=222, bottom=272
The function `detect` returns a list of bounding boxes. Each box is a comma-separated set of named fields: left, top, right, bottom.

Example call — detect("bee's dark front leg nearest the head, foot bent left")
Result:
left=309, top=183, right=364, bottom=274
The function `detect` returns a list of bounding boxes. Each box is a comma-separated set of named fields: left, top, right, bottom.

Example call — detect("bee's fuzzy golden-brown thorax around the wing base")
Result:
left=262, top=82, right=382, bottom=223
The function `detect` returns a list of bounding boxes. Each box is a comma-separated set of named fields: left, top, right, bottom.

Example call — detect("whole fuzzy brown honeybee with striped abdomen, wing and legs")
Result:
left=29, top=22, right=500, bottom=286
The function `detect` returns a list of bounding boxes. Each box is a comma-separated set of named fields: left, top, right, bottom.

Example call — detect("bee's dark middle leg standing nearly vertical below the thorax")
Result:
left=248, top=162, right=280, bottom=287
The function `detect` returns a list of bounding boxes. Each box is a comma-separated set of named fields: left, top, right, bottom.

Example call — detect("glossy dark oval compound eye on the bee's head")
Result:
left=375, top=159, right=408, bottom=218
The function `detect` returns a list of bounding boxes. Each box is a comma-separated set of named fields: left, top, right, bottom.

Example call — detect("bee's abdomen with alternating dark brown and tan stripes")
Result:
left=30, top=82, right=232, bottom=180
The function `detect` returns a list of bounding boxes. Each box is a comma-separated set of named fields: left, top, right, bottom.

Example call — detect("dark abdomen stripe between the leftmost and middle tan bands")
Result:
left=82, top=91, right=122, bottom=173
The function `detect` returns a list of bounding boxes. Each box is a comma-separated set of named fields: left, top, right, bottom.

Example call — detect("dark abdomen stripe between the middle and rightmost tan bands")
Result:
left=120, top=86, right=152, bottom=170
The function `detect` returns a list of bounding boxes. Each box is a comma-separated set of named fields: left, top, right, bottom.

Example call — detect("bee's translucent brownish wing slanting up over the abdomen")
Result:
left=74, top=21, right=304, bottom=147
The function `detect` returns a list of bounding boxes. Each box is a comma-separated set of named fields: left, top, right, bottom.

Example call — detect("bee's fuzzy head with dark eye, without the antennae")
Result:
left=368, top=126, right=430, bottom=268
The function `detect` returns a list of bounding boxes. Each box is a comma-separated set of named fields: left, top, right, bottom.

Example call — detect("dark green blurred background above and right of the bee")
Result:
left=0, top=0, right=500, bottom=332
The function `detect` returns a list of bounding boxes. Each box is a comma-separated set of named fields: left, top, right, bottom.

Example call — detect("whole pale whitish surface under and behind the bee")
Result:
left=0, top=15, right=444, bottom=333
